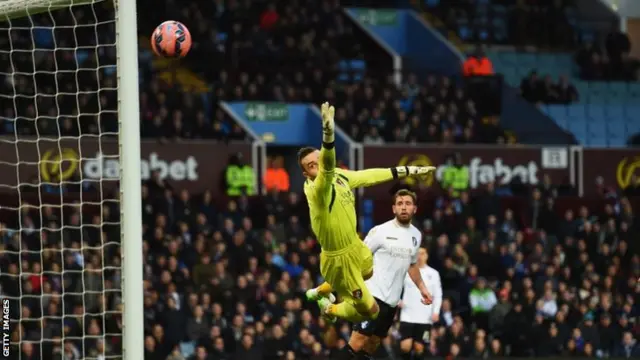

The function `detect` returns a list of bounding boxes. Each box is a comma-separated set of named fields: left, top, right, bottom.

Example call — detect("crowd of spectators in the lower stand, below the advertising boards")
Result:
left=0, top=167, right=640, bottom=360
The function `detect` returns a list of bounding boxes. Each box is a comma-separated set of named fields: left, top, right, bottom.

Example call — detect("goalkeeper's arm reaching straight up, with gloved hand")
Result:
left=312, top=103, right=336, bottom=206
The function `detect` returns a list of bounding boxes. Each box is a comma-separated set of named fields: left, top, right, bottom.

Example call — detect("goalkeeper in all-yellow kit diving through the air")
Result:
left=298, top=103, right=436, bottom=322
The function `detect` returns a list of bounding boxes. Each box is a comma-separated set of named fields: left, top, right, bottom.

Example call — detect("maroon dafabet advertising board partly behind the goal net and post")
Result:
left=0, top=137, right=251, bottom=192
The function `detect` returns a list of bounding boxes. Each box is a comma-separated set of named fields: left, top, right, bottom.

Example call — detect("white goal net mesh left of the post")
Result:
left=0, top=0, right=122, bottom=359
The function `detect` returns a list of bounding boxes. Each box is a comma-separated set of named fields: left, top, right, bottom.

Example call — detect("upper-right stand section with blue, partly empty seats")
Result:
left=416, top=0, right=640, bottom=147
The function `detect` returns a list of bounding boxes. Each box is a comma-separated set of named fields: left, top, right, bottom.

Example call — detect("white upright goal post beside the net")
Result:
left=113, top=0, right=144, bottom=360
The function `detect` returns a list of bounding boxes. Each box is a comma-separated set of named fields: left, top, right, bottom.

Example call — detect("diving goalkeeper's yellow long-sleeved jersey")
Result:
left=304, top=148, right=393, bottom=251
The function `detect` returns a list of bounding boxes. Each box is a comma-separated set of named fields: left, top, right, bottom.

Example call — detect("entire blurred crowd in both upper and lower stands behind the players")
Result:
left=0, top=0, right=640, bottom=360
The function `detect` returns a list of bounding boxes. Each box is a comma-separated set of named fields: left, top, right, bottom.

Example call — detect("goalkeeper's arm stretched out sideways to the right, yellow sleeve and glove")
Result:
left=339, top=166, right=436, bottom=189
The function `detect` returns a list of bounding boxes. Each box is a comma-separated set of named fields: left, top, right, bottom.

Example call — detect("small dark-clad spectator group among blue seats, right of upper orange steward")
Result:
left=520, top=70, right=580, bottom=105
